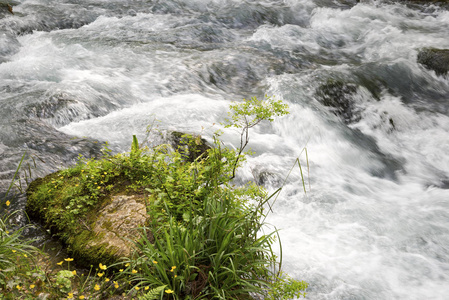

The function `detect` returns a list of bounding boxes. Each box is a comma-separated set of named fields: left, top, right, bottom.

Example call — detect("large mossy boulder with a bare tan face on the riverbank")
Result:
left=26, top=172, right=147, bottom=267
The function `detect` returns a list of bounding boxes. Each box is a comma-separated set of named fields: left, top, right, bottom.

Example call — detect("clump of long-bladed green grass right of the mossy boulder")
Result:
left=119, top=186, right=275, bottom=299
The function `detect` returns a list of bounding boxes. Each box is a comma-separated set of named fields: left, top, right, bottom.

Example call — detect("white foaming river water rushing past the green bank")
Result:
left=0, top=0, right=449, bottom=300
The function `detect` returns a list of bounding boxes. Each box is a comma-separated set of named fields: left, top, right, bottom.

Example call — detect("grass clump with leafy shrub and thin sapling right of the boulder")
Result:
left=112, top=98, right=306, bottom=299
